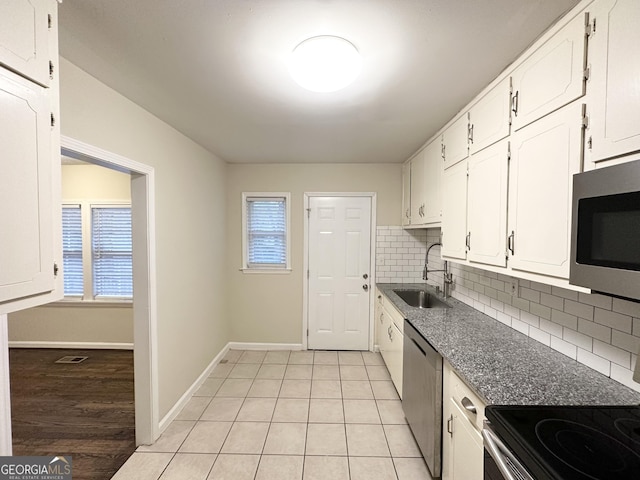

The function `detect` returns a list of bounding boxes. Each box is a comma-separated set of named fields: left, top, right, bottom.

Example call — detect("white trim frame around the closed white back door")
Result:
left=302, top=192, right=377, bottom=350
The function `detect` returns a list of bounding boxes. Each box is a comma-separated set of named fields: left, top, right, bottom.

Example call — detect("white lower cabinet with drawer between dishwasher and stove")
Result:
left=442, top=362, right=485, bottom=480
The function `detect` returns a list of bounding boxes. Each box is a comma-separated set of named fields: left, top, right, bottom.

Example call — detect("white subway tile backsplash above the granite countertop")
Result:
left=376, top=226, right=640, bottom=392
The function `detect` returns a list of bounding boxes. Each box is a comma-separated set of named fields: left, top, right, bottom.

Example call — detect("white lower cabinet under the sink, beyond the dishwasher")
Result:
left=375, top=290, right=404, bottom=398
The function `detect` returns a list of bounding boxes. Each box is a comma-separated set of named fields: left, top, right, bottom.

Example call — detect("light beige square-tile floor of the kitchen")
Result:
left=113, top=350, right=431, bottom=480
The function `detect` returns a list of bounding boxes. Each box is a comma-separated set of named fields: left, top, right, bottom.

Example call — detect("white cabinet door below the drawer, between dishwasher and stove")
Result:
left=442, top=398, right=484, bottom=480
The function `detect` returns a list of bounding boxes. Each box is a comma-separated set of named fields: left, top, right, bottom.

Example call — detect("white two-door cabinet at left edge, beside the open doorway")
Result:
left=0, top=0, right=62, bottom=314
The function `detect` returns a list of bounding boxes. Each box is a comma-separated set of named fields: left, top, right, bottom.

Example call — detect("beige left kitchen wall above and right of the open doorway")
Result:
left=55, top=55, right=230, bottom=416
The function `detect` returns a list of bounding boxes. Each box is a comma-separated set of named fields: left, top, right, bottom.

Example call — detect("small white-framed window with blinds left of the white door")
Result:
left=242, top=193, right=290, bottom=271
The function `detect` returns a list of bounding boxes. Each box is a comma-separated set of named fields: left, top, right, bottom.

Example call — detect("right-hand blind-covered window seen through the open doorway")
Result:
left=91, top=206, right=133, bottom=298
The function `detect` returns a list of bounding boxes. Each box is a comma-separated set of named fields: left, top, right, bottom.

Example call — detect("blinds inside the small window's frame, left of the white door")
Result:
left=246, top=197, right=287, bottom=268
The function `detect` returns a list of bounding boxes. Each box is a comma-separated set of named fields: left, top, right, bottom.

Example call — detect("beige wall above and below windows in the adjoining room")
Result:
left=9, top=165, right=133, bottom=344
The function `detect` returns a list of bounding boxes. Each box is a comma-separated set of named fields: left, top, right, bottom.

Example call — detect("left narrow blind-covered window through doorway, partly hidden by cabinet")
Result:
left=62, top=205, right=84, bottom=297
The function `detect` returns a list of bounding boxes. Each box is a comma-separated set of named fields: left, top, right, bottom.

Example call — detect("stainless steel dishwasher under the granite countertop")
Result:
left=402, top=320, right=442, bottom=478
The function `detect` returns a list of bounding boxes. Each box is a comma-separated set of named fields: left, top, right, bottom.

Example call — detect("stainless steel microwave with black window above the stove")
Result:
left=569, top=160, right=640, bottom=301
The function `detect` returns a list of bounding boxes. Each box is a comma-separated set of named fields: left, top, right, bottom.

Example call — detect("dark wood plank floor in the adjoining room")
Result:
left=9, top=348, right=135, bottom=480
